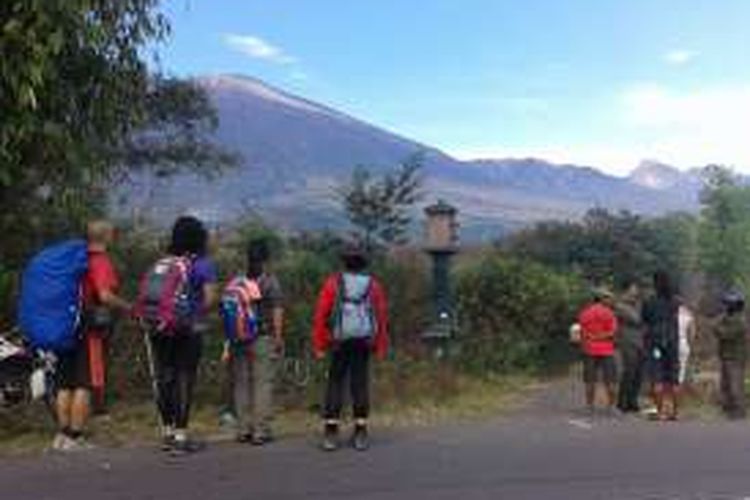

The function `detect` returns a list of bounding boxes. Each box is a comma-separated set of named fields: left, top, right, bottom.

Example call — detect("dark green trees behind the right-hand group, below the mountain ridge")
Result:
left=501, top=209, right=697, bottom=287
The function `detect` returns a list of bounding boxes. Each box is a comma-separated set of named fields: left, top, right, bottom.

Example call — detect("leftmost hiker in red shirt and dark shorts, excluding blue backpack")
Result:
left=52, top=220, right=131, bottom=451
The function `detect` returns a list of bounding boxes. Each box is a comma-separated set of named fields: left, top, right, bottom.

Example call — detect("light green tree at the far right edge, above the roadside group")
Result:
left=699, top=166, right=750, bottom=288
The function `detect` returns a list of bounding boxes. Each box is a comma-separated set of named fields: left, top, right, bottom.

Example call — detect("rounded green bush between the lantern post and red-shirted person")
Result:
left=456, top=253, right=587, bottom=373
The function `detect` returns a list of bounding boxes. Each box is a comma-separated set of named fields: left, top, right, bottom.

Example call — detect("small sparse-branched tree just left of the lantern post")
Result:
left=335, top=155, right=424, bottom=249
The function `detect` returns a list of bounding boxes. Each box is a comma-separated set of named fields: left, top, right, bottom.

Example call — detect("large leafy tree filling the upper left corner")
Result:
left=0, top=0, right=235, bottom=267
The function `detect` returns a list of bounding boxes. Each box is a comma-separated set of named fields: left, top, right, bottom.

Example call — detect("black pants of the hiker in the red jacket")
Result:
left=323, top=340, right=370, bottom=420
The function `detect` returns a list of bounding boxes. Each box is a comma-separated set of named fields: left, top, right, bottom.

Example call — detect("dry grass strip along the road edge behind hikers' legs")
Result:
left=0, top=364, right=536, bottom=456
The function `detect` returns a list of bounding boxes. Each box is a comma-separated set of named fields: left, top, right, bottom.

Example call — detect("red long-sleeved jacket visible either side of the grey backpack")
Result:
left=312, top=273, right=388, bottom=359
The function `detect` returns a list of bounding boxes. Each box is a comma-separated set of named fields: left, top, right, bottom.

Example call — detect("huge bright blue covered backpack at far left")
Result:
left=18, top=240, right=88, bottom=353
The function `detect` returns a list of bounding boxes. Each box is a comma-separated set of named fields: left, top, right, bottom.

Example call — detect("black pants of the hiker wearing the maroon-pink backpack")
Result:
left=151, top=334, right=203, bottom=429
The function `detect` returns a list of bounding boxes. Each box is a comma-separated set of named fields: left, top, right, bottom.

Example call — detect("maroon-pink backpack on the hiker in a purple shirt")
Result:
left=135, top=256, right=195, bottom=336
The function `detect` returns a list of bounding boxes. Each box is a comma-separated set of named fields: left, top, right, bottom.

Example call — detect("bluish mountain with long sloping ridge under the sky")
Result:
left=119, top=75, right=698, bottom=237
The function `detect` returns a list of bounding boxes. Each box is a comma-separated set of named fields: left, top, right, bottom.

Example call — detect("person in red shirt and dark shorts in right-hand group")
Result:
left=578, top=288, right=618, bottom=415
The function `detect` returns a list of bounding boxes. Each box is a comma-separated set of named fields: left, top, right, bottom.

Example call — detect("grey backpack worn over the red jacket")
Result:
left=331, top=273, right=376, bottom=341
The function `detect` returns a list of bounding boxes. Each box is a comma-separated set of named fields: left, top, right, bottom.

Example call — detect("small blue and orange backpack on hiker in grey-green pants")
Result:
left=219, top=276, right=262, bottom=344
